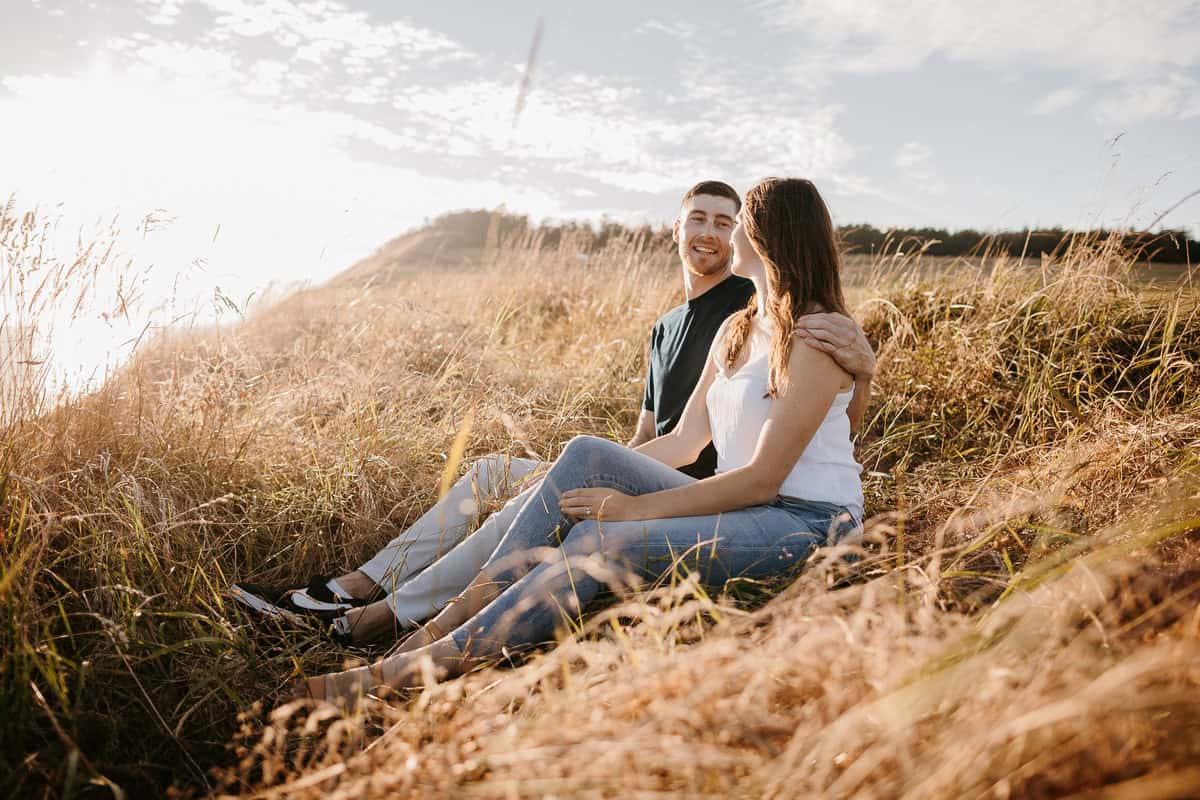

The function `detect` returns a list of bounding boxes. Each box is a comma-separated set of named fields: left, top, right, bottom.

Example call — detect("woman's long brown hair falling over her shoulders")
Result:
left=722, top=178, right=846, bottom=397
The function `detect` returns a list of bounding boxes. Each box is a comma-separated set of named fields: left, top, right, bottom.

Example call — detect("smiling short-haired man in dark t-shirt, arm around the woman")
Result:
left=232, top=181, right=875, bottom=642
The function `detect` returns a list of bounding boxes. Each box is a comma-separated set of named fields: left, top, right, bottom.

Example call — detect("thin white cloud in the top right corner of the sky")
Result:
left=756, top=0, right=1200, bottom=136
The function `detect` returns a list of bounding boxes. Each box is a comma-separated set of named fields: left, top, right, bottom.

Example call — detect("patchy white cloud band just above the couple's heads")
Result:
left=384, top=74, right=853, bottom=192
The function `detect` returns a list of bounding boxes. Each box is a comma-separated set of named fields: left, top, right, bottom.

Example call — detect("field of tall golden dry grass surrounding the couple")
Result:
left=0, top=216, right=1200, bottom=798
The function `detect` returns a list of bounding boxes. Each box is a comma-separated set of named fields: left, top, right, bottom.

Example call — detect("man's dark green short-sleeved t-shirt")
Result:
left=642, top=275, right=754, bottom=477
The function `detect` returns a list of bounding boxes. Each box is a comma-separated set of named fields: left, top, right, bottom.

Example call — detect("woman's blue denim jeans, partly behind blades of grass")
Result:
left=451, top=437, right=857, bottom=658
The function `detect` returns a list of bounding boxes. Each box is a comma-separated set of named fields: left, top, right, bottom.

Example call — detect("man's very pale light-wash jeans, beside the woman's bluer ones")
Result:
left=359, top=455, right=541, bottom=626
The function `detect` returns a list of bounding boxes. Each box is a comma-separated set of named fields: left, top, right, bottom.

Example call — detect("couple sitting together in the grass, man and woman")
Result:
left=234, top=179, right=875, bottom=703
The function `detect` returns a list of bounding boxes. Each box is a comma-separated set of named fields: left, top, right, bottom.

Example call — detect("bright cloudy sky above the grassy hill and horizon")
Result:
left=0, top=0, right=1200, bottom=381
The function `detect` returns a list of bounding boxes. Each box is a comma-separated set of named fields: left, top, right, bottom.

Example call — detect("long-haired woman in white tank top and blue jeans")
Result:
left=301, top=178, right=863, bottom=703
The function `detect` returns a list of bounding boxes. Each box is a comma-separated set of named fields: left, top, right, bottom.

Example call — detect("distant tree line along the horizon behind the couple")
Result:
left=426, top=209, right=1200, bottom=264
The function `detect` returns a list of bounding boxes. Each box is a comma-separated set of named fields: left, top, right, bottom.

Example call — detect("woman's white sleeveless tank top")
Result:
left=706, top=324, right=863, bottom=523
